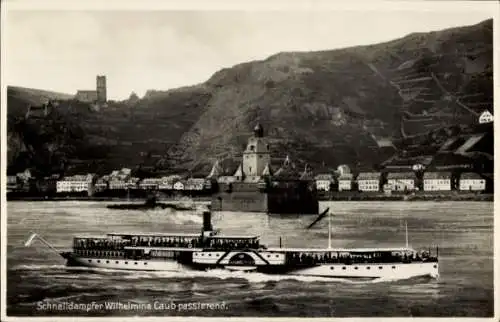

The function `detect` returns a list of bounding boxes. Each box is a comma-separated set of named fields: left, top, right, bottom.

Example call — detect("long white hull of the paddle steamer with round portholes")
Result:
left=61, top=254, right=439, bottom=280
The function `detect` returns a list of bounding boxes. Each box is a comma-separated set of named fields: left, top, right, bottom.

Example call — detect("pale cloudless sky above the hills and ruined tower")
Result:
left=2, top=2, right=492, bottom=99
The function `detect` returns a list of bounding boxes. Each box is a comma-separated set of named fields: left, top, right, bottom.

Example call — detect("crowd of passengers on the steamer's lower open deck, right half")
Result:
left=286, top=251, right=431, bottom=265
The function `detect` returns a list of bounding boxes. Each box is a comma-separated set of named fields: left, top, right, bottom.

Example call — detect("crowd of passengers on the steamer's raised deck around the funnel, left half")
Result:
left=74, top=236, right=259, bottom=250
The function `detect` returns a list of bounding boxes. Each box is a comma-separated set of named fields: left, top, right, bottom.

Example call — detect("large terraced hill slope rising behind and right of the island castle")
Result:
left=171, top=20, right=493, bottom=172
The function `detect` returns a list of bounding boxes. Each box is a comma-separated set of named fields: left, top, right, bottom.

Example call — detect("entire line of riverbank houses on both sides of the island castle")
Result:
left=7, top=168, right=486, bottom=195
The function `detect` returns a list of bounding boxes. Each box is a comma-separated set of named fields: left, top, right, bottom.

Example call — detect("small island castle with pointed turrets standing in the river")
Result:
left=209, top=124, right=319, bottom=214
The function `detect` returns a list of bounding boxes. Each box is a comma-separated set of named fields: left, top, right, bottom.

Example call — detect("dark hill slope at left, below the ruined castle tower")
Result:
left=7, top=86, right=209, bottom=173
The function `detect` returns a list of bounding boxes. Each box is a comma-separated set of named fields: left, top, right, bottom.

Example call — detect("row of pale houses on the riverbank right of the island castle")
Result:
left=315, top=172, right=486, bottom=191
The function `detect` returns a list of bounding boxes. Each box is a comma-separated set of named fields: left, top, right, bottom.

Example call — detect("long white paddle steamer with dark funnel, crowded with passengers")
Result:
left=25, top=211, right=439, bottom=279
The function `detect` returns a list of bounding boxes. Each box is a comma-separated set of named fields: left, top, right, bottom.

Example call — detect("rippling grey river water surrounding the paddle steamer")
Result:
left=7, top=201, right=494, bottom=317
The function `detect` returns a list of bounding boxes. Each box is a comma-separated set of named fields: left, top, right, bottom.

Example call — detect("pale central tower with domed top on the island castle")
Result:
left=243, top=124, right=271, bottom=178
